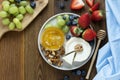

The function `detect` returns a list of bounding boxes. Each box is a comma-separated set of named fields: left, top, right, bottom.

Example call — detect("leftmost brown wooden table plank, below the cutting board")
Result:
left=0, top=32, right=24, bottom=80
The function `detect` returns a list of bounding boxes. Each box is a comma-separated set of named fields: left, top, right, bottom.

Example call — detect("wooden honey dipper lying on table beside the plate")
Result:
left=86, top=30, right=106, bottom=79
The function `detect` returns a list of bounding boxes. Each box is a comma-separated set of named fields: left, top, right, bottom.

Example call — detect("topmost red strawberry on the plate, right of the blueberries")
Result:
left=78, top=13, right=90, bottom=29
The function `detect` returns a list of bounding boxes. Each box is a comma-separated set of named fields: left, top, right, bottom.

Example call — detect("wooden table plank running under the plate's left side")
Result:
left=24, top=0, right=54, bottom=80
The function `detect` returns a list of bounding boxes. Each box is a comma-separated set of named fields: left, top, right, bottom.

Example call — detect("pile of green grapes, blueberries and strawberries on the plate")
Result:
left=45, top=13, right=96, bottom=41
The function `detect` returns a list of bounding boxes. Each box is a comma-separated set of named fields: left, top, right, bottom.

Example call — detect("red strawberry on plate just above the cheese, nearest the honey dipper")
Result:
left=82, top=28, right=96, bottom=41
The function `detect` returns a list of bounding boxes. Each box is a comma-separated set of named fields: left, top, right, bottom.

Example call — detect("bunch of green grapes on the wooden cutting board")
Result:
left=0, top=0, right=36, bottom=30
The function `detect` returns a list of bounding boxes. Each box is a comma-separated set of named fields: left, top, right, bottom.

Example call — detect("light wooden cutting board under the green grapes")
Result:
left=0, top=0, right=48, bottom=39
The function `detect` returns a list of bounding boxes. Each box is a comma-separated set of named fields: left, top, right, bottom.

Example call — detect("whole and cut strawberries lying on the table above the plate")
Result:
left=70, top=0, right=104, bottom=21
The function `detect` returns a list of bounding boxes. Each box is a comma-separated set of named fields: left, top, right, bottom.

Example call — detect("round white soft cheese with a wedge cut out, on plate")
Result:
left=65, top=37, right=91, bottom=62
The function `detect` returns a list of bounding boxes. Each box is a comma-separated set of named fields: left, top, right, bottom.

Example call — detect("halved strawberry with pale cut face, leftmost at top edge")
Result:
left=70, top=0, right=85, bottom=10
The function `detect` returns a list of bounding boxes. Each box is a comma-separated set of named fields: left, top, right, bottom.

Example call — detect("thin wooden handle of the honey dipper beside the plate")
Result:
left=86, top=39, right=101, bottom=79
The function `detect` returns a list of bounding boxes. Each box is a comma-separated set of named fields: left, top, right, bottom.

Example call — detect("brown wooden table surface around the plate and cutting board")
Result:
left=0, top=0, right=107, bottom=80
